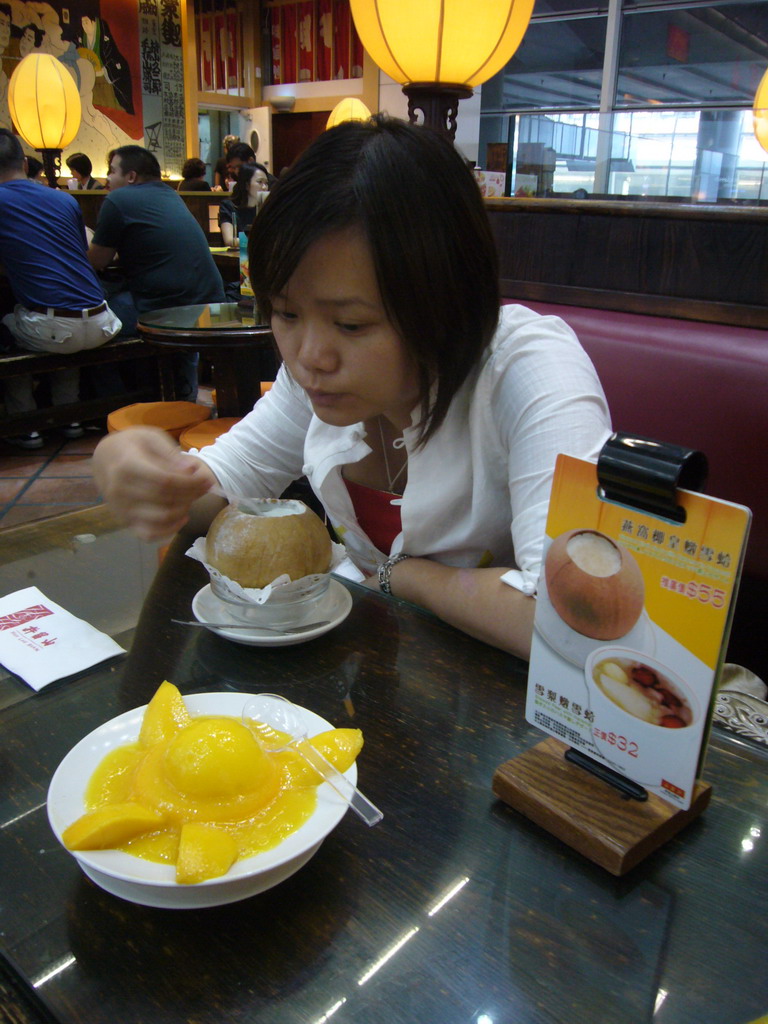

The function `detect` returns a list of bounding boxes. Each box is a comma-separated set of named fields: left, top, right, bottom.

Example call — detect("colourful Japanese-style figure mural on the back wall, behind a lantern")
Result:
left=0, top=0, right=185, bottom=177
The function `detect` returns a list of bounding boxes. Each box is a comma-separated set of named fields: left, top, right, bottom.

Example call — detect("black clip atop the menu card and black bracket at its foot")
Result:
left=565, top=432, right=708, bottom=801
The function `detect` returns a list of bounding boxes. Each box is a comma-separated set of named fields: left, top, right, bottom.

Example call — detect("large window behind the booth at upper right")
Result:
left=479, top=0, right=768, bottom=203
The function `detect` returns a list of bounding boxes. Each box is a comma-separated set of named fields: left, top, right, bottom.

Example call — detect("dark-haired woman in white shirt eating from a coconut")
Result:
left=95, top=116, right=610, bottom=657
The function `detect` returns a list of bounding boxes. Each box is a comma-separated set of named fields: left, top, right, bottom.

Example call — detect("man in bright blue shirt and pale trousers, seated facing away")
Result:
left=0, top=128, right=120, bottom=449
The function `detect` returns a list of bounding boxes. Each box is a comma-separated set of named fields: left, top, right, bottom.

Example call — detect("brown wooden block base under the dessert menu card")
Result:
left=493, top=736, right=712, bottom=876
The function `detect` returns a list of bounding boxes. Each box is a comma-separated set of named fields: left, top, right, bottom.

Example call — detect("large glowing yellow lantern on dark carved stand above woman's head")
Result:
left=350, top=0, right=534, bottom=138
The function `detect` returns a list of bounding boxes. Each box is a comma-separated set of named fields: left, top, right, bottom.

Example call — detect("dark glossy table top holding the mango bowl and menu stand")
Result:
left=0, top=520, right=768, bottom=1024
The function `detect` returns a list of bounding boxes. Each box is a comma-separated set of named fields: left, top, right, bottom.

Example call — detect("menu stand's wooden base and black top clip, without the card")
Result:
left=493, top=433, right=712, bottom=876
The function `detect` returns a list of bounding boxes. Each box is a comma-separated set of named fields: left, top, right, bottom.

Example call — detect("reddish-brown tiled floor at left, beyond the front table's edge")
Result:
left=0, top=430, right=102, bottom=528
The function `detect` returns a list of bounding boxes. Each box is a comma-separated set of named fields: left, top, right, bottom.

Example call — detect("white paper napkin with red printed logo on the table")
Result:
left=0, top=587, right=124, bottom=690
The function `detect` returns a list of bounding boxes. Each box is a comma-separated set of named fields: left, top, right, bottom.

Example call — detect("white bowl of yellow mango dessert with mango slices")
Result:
left=48, top=682, right=362, bottom=908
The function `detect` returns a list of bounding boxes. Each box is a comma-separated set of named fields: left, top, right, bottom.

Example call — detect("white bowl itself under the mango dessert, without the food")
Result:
left=48, top=692, right=357, bottom=909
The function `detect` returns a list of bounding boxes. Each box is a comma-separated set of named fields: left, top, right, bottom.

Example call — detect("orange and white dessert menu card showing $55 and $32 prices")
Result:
left=526, top=456, right=751, bottom=809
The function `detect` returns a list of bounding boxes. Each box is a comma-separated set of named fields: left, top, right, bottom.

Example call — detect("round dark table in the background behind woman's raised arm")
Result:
left=138, top=302, right=278, bottom=417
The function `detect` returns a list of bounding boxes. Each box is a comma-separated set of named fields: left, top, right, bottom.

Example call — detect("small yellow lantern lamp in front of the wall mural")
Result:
left=8, top=53, right=82, bottom=188
